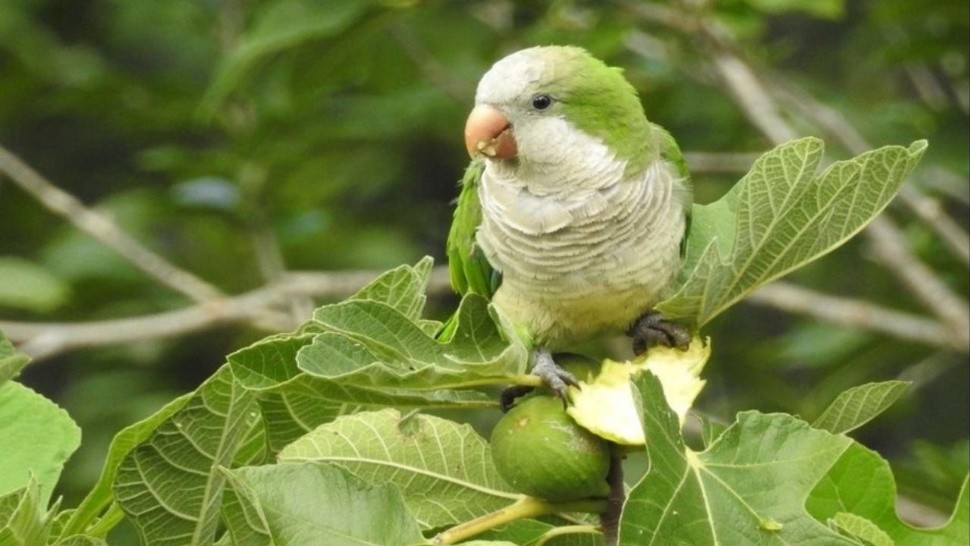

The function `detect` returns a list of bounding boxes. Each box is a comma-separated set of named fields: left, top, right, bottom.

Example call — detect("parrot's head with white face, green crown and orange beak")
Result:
left=465, top=46, right=651, bottom=174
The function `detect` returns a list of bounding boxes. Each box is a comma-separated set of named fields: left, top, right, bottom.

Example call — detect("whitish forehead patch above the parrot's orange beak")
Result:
left=475, top=47, right=547, bottom=104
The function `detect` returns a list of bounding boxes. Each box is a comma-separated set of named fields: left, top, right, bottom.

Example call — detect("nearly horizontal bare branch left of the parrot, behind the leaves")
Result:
left=0, top=267, right=450, bottom=361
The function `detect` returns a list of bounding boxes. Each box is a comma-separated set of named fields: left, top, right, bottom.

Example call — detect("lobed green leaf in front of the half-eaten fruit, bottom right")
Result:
left=620, top=374, right=855, bottom=546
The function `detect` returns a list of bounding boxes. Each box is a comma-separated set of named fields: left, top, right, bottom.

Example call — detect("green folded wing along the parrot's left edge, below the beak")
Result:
left=447, top=159, right=500, bottom=298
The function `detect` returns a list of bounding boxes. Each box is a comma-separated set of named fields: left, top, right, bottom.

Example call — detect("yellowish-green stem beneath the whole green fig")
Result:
left=431, top=495, right=606, bottom=544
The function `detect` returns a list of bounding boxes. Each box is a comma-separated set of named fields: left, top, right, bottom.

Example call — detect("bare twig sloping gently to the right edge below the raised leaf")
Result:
left=744, top=281, right=970, bottom=353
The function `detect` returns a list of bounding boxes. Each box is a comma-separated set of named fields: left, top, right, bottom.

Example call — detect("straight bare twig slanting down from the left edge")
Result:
left=0, top=146, right=223, bottom=302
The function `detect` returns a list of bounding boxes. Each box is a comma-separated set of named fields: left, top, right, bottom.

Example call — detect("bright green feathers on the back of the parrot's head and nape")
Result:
left=549, top=47, right=659, bottom=173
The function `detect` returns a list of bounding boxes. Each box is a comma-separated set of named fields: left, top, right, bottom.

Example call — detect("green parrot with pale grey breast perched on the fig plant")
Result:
left=447, top=46, right=692, bottom=404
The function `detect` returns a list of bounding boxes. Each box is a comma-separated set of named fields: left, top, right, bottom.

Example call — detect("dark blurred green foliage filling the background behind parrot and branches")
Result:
left=0, top=0, right=970, bottom=528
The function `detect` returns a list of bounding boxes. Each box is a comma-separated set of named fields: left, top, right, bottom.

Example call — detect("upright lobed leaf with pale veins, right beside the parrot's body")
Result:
left=656, top=138, right=926, bottom=326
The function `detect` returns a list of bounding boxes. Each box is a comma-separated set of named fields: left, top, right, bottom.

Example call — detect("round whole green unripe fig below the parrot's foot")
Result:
left=491, top=395, right=610, bottom=501
